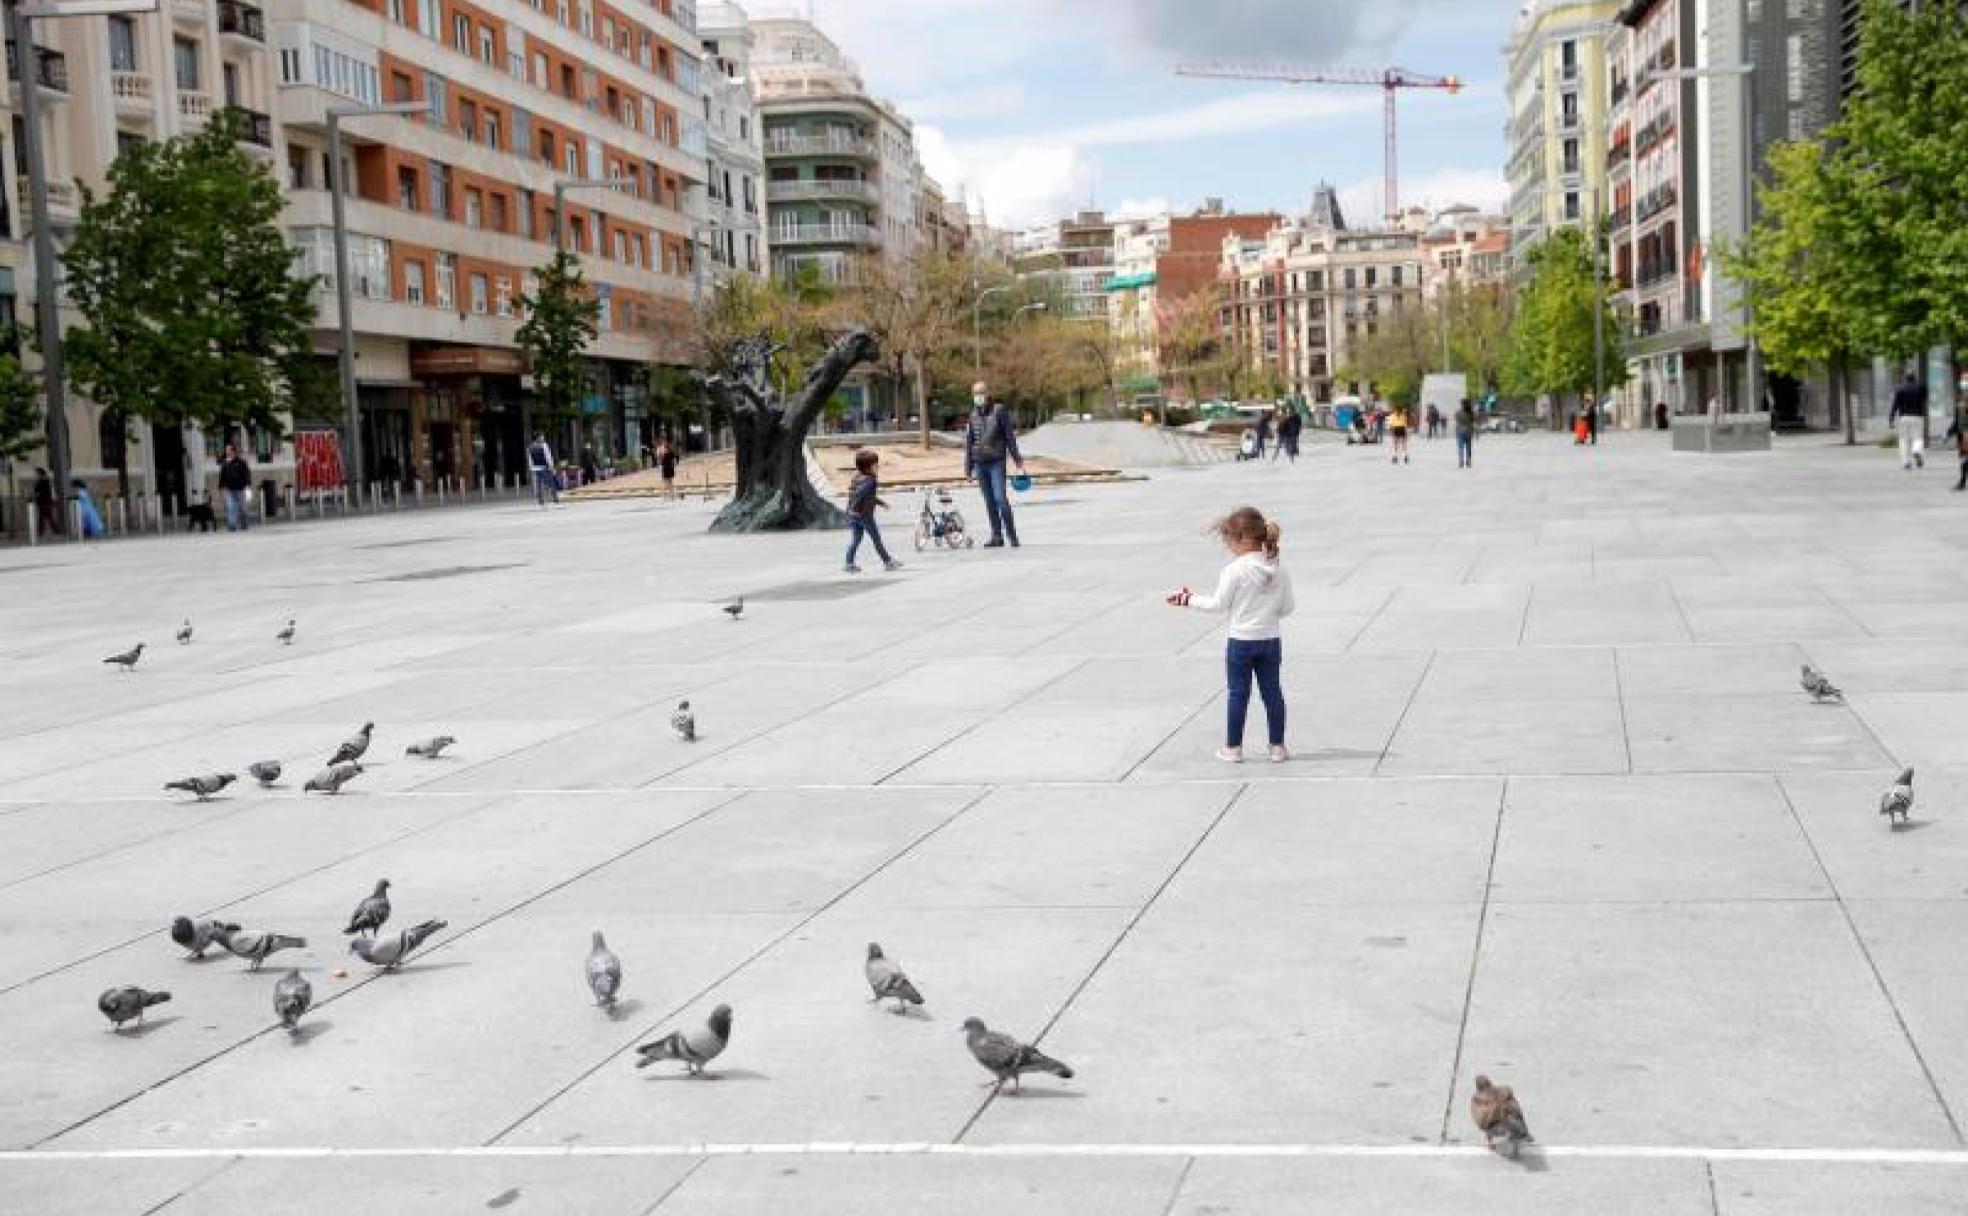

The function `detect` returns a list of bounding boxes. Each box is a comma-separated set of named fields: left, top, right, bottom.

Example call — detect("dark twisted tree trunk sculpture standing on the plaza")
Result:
left=703, top=331, right=878, bottom=531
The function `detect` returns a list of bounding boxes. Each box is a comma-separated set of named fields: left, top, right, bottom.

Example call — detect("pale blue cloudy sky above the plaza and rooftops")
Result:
left=783, top=0, right=1519, bottom=226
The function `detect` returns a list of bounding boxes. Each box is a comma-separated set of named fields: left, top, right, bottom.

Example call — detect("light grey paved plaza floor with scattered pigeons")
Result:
left=0, top=435, right=1968, bottom=1216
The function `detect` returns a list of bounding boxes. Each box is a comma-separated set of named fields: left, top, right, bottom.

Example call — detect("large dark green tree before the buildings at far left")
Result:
left=63, top=112, right=315, bottom=494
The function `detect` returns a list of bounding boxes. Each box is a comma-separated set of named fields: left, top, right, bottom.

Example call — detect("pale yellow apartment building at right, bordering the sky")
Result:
left=1504, top=0, right=1620, bottom=268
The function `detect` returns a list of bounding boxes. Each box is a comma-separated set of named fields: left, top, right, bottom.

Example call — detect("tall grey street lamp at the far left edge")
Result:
left=6, top=0, right=157, bottom=527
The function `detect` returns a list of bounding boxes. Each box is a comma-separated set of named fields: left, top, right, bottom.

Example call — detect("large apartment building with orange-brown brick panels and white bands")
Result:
left=273, top=0, right=707, bottom=480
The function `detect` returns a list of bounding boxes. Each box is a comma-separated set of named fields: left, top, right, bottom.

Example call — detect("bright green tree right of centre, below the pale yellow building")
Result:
left=1502, top=228, right=1626, bottom=409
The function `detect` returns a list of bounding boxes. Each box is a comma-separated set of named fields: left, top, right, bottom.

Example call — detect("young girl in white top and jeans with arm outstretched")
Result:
left=1169, top=508, right=1297, bottom=763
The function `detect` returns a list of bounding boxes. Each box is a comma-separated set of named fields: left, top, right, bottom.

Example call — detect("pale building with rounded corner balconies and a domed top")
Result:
left=752, top=18, right=921, bottom=283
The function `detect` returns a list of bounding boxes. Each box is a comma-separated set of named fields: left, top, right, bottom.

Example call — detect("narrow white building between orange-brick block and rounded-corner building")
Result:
left=693, top=4, right=769, bottom=291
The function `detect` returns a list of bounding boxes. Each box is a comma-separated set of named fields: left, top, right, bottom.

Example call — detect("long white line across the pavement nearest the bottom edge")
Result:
left=0, top=1141, right=1968, bottom=1169
